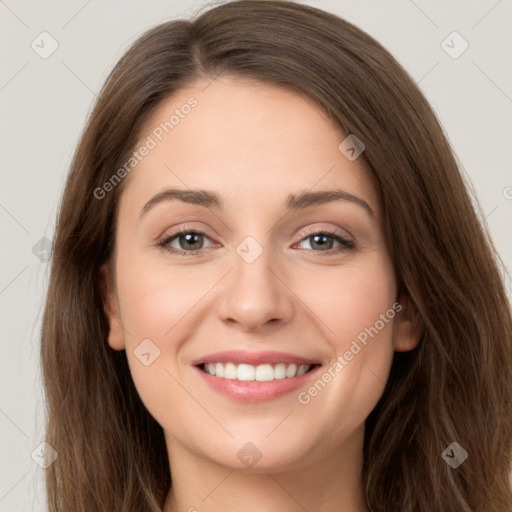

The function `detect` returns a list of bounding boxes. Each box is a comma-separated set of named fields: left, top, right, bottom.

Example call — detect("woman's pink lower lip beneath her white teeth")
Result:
left=193, top=365, right=320, bottom=402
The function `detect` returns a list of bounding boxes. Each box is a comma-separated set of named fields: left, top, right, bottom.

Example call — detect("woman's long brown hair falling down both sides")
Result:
left=41, top=0, right=512, bottom=512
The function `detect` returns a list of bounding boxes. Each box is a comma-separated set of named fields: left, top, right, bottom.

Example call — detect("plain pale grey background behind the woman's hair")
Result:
left=0, top=0, right=512, bottom=512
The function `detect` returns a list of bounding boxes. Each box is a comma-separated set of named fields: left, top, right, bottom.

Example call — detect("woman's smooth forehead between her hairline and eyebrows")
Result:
left=119, top=77, right=377, bottom=217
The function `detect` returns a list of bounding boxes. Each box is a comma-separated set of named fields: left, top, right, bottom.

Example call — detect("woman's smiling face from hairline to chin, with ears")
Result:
left=102, top=78, right=416, bottom=470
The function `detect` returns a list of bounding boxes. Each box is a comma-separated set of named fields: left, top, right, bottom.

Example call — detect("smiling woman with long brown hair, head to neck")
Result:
left=42, top=0, right=512, bottom=512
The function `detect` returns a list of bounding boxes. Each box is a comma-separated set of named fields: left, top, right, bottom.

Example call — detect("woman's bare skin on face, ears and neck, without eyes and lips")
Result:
left=102, top=77, right=420, bottom=512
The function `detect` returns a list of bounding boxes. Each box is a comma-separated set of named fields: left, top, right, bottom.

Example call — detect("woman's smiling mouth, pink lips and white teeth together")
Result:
left=192, top=351, right=322, bottom=403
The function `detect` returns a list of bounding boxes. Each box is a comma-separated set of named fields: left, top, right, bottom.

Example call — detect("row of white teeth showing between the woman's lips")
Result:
left=203, top=363, right=311, bottom=382
